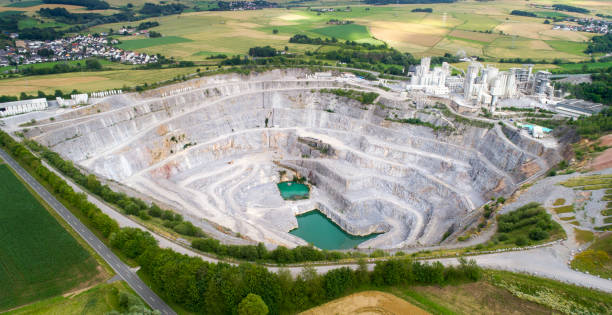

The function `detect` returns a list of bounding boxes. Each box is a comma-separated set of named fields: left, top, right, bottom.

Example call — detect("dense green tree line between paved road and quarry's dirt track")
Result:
left=0, top=131, right=482, bottom=314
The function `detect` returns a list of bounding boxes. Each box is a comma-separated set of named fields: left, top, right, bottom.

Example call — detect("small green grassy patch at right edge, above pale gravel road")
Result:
left=572, top=233, right=612, bottom=278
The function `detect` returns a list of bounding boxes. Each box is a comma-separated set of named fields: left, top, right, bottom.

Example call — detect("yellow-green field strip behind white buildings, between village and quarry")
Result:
left=0, top=67, right=197, bottom=95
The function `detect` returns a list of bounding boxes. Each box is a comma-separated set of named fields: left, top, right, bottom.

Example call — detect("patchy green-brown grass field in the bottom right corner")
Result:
left=385, top=270, right=612, bottom=315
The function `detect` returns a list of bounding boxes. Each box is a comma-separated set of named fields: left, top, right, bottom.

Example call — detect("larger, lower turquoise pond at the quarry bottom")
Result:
left=289, top=210, right=379, bottom=250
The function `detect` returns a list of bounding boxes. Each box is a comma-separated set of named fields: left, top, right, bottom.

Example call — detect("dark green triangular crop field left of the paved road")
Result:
left=0, top=165, right=99, bottom=311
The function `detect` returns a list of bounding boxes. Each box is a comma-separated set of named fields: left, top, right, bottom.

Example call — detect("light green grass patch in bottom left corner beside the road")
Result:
left=7, top=281, right=142, bottom=315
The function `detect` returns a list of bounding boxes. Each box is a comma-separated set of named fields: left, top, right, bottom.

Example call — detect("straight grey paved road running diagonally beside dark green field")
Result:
left=0, top=149, right=176, bottom=315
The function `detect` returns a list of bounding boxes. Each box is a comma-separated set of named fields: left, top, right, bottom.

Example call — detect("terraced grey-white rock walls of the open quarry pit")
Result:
left=29, top=70, right=560, bottom=248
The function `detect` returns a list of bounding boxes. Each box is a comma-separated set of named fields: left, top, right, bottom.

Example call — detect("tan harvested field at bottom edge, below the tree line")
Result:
left=300, top=291, right=430, bottom=315
